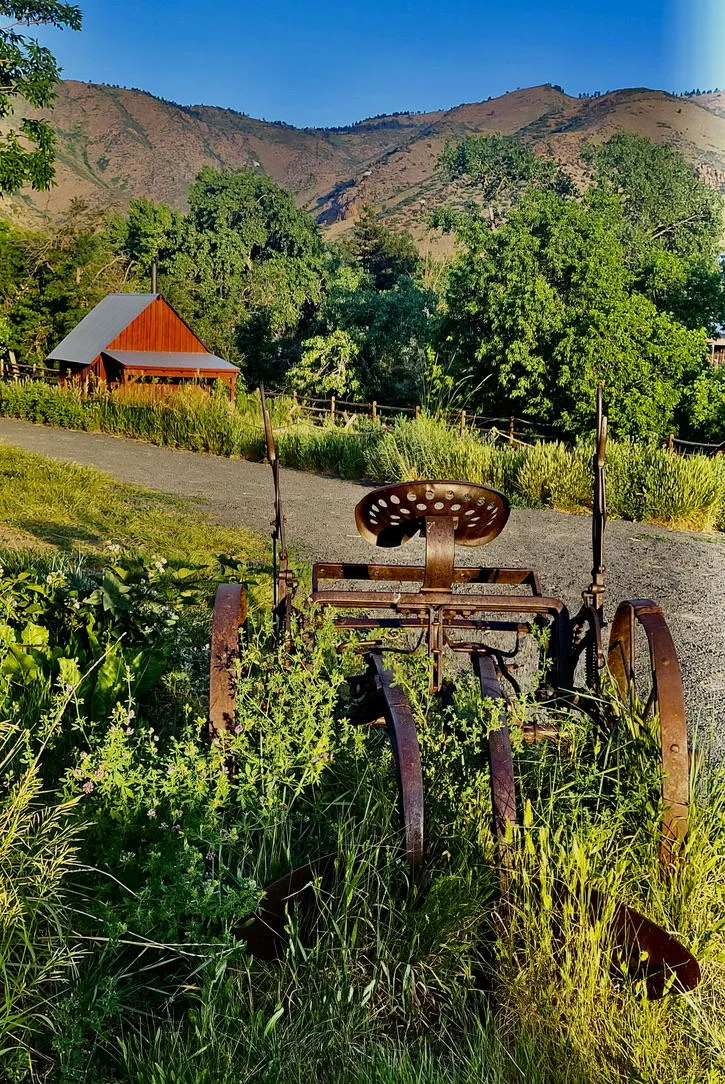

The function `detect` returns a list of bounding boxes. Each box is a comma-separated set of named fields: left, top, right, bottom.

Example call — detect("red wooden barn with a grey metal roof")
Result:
left=48, top=294, right=239, bottom=398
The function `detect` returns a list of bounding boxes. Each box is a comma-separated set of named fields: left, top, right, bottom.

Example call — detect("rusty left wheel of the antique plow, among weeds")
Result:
left=209, top=583, right=247, bottom=740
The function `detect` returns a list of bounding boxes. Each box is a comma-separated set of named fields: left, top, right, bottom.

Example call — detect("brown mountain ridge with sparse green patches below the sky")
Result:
left=0, top=80, right=725, bottom=234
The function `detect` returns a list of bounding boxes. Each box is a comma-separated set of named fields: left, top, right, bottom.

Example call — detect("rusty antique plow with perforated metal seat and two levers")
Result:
left=210, top=389, right=699, bottom=996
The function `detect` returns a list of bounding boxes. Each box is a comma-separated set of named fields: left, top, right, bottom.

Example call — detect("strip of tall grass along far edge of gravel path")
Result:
left=0, top=384, right=725, bottom=530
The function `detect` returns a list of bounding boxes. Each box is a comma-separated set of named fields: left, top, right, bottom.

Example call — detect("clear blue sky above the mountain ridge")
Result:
left=36, top=0, right=725, bottom=126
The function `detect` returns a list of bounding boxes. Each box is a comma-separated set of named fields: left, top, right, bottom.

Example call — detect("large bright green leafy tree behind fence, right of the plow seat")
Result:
left=440, top=189, right=705, bottom=438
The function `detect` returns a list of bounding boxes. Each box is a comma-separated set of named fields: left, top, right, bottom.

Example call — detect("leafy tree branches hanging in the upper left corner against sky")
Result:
left=0, top=0, right=82, bottom=196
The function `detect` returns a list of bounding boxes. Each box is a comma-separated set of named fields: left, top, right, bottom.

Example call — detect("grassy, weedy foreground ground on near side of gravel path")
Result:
left=0, top=449, right=725, bottom=1084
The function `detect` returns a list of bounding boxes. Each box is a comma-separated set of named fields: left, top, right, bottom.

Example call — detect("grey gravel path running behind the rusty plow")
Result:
left=0, top=418, right=725, bottom=737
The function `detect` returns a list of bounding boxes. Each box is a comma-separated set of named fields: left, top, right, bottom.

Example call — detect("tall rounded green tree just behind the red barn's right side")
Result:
left=159, top=167, right=328, bottom=382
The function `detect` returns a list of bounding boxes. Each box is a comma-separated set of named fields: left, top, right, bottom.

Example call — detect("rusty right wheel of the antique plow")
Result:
left=608, top=598, right=689, bottom=865
